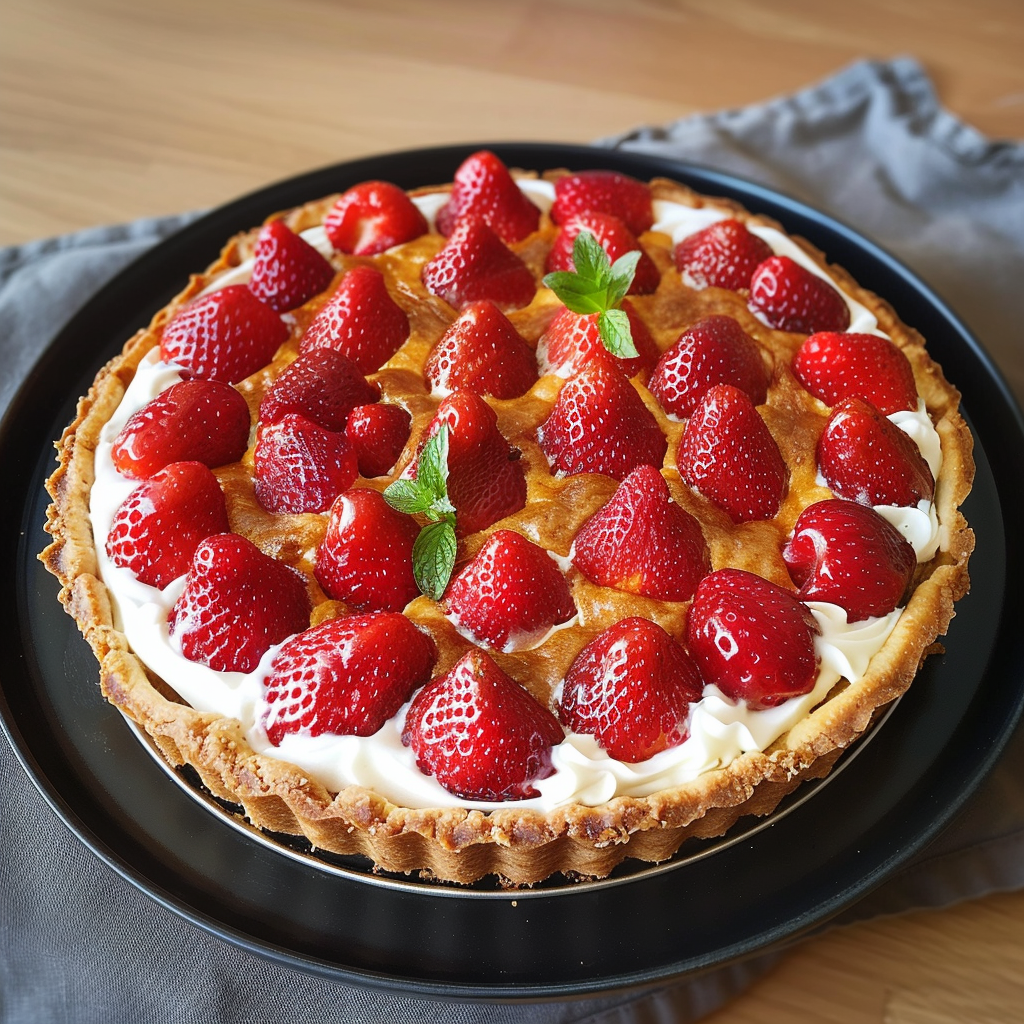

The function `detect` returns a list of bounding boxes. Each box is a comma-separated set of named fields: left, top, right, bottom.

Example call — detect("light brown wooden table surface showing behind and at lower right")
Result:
left=0, top=0, right=1024, bottom=1024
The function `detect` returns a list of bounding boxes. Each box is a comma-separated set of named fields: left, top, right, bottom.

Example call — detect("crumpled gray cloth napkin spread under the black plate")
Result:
left=0, top=59, right=1024, bottom=1024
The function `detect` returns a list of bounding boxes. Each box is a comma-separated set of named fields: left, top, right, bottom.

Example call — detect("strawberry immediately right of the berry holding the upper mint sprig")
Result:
left=647, top=315, right=768, bottom=420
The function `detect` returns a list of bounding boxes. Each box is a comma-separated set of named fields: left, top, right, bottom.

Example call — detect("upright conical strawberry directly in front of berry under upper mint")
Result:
left=538, top=359, right=668, bottom=480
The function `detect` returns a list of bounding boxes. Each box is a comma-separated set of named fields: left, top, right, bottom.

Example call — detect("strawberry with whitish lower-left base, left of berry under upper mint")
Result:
left=423, top=299, right=537, bottom=398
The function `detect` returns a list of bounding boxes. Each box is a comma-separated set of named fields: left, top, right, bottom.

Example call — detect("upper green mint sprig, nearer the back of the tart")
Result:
left=544, top=231, right=640, bottom=359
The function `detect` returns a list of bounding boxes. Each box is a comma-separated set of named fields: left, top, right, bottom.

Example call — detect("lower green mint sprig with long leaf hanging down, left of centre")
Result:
left=384, top=423, right=458, bottom=601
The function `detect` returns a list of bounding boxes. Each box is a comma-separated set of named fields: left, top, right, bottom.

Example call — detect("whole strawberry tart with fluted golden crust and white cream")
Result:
left=41, top=151, right=974, bottom=886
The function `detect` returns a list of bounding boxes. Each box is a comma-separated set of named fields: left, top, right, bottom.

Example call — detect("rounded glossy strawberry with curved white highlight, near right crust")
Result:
left=782, top=499, right=918, bottom=623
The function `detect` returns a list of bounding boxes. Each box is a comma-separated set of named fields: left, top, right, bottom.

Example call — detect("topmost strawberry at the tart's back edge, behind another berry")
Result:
left=435, top=150, right=541, bottom=243
